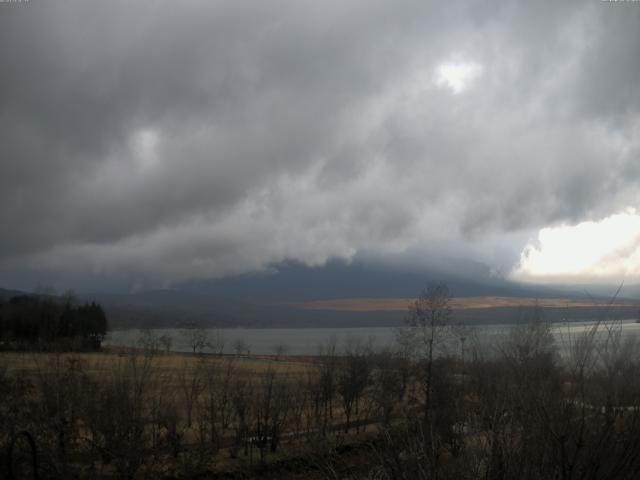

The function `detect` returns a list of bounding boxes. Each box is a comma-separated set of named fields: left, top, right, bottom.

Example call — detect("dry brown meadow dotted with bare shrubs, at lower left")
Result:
left=0, top=348, right=410, bottom=478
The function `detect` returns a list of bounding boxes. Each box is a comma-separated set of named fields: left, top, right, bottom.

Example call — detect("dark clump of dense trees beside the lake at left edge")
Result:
left=0, top=295, right=107, bottom=349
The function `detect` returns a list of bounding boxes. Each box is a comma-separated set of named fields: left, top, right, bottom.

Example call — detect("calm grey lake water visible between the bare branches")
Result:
left=106, top=320, right=640, bottom=355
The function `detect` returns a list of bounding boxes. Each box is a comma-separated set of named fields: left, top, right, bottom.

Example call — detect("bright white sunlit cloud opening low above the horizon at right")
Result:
left=512, top=208, right=640, bottom=283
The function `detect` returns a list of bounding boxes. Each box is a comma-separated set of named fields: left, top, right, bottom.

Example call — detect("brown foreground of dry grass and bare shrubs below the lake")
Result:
left=0, top=286, right=640, bottom=480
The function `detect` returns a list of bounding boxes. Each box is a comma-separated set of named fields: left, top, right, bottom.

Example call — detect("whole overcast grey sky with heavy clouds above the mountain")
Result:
left=0, top=0, right=640, bottom=286
